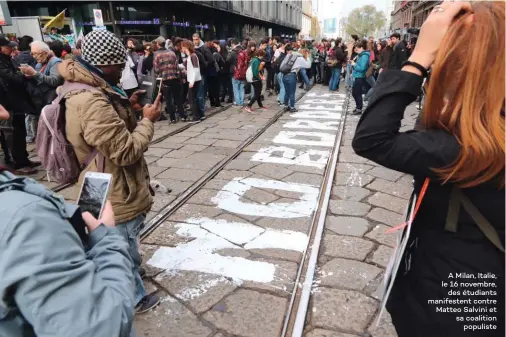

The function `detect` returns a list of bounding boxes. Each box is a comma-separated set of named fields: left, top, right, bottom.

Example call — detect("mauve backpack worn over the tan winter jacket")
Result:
left=36, top=81, right=103, bottom=184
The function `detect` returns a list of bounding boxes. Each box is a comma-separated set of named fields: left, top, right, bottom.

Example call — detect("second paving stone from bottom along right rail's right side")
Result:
left=320, top=258, right=381, bottom=290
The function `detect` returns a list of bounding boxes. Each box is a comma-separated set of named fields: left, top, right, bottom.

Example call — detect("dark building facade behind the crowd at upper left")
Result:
left=8, top=0, right=302, bottom=40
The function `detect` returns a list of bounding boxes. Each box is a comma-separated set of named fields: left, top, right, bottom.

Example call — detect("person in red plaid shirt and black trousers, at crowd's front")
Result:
left=153, top=36, right=186, bottom=123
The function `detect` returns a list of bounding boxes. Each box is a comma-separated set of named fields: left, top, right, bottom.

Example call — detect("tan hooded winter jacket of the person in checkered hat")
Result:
left=58, top=60, right=154, bottom=224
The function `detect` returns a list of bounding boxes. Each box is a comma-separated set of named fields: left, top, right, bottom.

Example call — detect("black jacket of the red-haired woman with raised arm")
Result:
left=352, top=70, right=505, bottom=337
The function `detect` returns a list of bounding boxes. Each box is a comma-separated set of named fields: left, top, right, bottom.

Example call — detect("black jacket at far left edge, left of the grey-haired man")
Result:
left=0, top=53, right=36, bottom=114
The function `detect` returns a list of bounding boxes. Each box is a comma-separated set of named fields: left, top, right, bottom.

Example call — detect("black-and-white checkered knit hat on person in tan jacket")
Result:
left=81, top=30, right=126, bottom=66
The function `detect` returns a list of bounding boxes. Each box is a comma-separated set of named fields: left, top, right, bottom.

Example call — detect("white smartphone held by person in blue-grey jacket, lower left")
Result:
left=77, top=172, right=112, bottom=219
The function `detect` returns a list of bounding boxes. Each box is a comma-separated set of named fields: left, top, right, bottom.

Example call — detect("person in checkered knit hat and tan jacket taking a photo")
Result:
left=58, top=30, right=161, bottom=313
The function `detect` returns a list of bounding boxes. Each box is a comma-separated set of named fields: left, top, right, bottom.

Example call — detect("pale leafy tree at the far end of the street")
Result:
left=344, top=5, right=386, bottom=39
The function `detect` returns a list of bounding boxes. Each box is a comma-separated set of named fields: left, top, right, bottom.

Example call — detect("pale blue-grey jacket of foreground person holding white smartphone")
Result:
left=0, top=171, right=135, bottom=337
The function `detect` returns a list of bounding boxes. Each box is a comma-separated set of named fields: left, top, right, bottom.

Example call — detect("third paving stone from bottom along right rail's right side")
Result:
left=323, top=234, right=375, bottom=262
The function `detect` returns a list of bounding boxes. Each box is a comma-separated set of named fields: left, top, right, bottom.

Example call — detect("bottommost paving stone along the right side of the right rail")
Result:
left=312, top=288, right=377, bottom=333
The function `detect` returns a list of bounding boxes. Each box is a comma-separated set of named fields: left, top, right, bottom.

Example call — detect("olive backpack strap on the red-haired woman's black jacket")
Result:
left=445, top=186, right=505, bottom=253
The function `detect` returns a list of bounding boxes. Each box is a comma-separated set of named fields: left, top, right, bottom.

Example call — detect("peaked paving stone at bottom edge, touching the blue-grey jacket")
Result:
left=135, top=294, right=212, bottom=337
